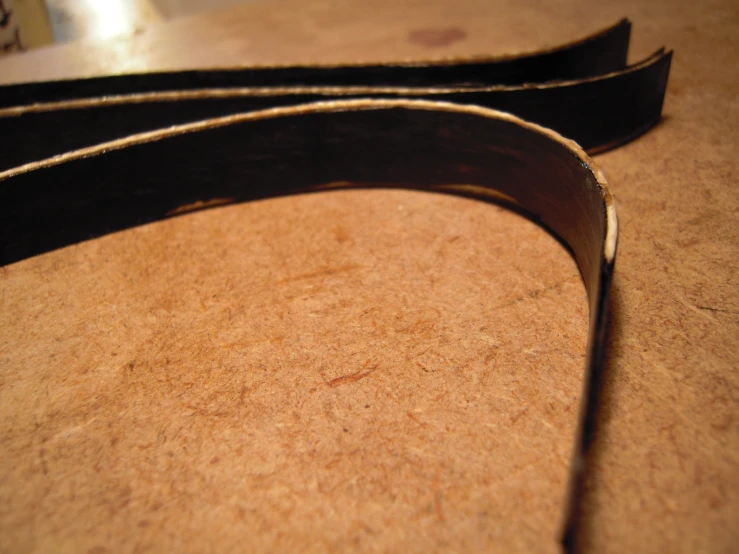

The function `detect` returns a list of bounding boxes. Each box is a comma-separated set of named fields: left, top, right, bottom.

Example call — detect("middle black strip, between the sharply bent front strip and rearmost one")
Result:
left=0, top=51, right=671, bottom=169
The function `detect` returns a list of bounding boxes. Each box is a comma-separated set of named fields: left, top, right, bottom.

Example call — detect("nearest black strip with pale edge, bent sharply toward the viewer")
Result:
left=0, top=100, right=618, bottom=549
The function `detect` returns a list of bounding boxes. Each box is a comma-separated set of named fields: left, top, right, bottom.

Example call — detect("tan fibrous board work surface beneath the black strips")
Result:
left=0, top=0, right=739, bottom=553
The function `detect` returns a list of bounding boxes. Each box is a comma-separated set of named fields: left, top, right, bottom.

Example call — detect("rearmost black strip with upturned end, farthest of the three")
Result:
left=0, top=19, right=631, bottom=108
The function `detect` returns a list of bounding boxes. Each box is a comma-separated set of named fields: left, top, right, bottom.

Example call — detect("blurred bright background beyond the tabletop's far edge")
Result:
left=0, top=0, right=258, bottom=55
